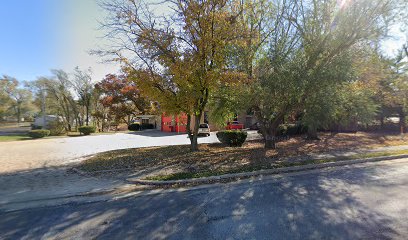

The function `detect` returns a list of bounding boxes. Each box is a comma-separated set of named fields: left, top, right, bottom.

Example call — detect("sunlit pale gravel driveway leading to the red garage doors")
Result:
left=0, top=131, right=257, bottom=174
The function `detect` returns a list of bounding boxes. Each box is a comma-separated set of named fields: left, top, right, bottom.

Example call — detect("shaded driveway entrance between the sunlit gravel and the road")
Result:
left=0, top=165, right=124, bottom=212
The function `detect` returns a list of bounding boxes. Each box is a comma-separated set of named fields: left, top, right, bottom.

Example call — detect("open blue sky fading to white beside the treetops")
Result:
left=0, top=0, right=405, bottom=81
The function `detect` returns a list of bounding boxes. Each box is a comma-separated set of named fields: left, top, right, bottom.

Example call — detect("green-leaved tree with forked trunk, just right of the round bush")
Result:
left=251, top=0, right=392, bottom=148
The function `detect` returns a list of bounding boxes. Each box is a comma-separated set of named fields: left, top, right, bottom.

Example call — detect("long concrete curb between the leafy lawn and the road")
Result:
left=126, top=154, right=408, bottom=186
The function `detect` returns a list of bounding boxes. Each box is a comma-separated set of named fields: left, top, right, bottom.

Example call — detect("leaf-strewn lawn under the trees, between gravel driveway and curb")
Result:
left=79, top=132, right=408, bottom=180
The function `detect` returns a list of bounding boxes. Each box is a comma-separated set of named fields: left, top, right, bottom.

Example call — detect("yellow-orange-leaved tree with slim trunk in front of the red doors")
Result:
left=99, top=0, right=249, bottom=151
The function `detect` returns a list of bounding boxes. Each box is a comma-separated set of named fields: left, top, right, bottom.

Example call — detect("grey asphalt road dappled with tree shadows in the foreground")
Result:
left=0, top=159, right=408, bottom=239
